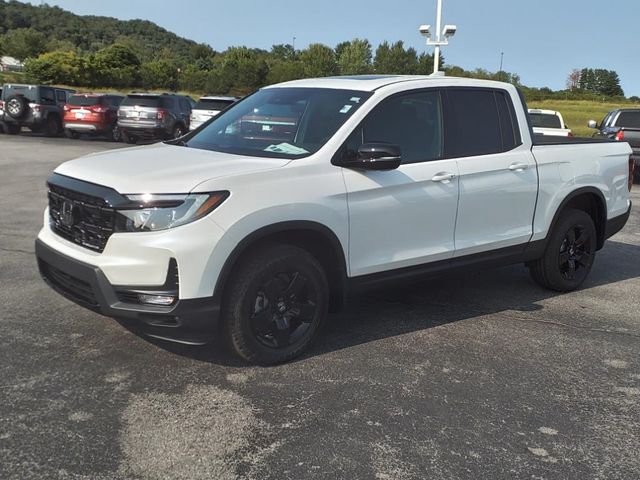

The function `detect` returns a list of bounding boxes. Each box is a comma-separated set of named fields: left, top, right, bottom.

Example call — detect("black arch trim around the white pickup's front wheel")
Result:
left=214, top=220, right=347, bottom=312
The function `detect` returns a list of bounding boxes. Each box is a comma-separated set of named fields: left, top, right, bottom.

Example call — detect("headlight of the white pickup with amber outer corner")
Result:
left=115, top=192, right=229, bottom=232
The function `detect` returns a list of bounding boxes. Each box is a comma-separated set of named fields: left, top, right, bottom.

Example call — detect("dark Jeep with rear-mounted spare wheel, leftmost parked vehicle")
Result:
left=0, top=84, right=75, bottom=136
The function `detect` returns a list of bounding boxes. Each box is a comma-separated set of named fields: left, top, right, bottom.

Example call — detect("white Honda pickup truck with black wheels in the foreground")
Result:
left=36, top=76, right=633, bottom=364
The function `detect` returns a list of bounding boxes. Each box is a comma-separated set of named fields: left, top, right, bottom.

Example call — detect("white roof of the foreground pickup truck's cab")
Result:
left=265, top=75, right=510, bottom=92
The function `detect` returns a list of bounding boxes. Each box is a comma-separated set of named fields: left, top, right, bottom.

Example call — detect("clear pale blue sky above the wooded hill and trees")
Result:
left=22, top=0, right=640, bottom=96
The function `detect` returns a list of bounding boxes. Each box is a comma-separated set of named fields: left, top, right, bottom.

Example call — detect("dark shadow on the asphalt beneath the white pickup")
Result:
left=132, top=241, right=640, bottom=367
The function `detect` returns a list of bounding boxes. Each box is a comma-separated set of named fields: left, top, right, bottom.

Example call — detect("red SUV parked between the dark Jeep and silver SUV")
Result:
left=64, top=93, right=124, bottom=142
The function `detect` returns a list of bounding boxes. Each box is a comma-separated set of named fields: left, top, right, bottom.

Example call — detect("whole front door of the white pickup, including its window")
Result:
left=343, top=89, right=458, bottom=276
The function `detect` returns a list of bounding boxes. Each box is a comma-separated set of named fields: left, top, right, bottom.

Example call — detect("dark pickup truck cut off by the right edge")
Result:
left=589, top=108, right=640, bottom=182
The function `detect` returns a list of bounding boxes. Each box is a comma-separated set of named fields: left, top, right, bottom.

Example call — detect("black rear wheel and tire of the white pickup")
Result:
left=529, top=209, right=597, bottom=292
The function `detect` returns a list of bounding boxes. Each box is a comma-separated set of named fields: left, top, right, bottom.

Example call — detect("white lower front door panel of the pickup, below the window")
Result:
left=343, top=160, right=458, bottom=276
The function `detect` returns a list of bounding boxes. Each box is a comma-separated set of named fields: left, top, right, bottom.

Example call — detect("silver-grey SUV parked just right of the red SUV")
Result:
left=118, top=93, right=193, bottom=143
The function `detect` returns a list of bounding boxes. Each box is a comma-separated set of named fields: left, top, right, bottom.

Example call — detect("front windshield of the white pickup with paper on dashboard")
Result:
left=185, top=88, right=371, bottom=158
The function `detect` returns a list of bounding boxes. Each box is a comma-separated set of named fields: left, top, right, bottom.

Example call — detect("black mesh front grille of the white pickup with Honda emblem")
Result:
left=49, top=184, right=115, bottom=252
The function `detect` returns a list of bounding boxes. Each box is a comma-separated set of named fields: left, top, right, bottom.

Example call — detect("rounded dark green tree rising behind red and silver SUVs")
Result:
left=88, top=44, right=140, bottom=87
